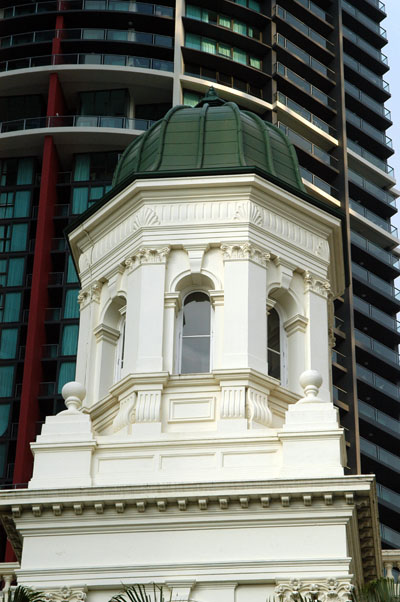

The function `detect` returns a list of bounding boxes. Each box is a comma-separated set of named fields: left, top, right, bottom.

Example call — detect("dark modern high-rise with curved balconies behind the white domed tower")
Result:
left=0, top=0, right=400, bottom=548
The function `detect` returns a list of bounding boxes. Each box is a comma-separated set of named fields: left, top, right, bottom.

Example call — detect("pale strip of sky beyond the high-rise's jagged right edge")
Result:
left=381, top=0, right=400, bottom=228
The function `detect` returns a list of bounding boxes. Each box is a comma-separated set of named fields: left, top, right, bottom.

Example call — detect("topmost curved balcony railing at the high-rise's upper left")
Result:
left=3, top=0, right=174, bottom=19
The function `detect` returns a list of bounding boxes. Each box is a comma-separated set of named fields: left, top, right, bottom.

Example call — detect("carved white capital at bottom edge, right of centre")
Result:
left=275, top=579, right=354, bottom=602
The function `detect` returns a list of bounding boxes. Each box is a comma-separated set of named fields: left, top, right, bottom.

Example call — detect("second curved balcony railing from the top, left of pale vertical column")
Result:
left=0, top=28, right=173, bottom=48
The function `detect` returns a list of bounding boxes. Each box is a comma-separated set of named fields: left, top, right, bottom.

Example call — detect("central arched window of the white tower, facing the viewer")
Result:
left=180, top=291, right=211, bottom=374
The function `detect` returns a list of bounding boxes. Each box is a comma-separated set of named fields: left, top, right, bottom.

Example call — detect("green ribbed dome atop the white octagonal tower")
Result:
left=113, top=88, right=304, bottom=192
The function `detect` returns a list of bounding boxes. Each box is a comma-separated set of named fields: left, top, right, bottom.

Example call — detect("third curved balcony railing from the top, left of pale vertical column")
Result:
left=0, top=53, right=174, bottom=72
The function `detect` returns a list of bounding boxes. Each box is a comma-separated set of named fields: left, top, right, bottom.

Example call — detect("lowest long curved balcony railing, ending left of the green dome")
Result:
left=0, top=115, right=154, bottom=134
